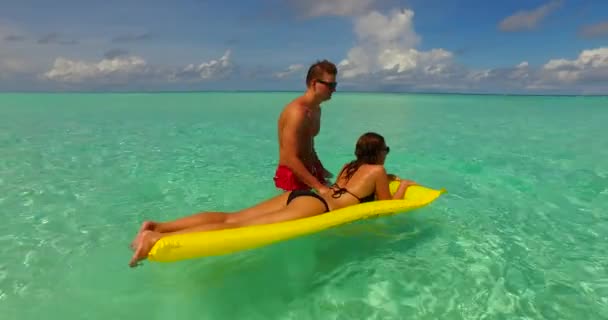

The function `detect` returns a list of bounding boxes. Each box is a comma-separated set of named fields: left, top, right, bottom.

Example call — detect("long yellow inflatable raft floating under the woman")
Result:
left=148, top=181, right=445, bottom=262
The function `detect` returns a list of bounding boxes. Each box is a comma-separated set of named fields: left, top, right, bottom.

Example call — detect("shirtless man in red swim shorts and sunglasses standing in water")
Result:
left=274, top=60, right=338, bottom=193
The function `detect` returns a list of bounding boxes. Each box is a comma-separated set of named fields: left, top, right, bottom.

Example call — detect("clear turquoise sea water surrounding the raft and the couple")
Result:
left=0, top=93, right=608, bottom=320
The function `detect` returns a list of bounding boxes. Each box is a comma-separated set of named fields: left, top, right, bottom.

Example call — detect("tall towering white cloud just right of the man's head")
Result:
left=338, top=10, right=453, bottom=80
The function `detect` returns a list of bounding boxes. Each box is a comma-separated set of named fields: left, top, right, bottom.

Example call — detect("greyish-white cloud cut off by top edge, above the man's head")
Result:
left=291, top=0, right=377, bottom=18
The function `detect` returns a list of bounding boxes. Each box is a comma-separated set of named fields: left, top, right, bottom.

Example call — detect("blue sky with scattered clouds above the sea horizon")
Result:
left=0, top=0, right=608, bottom=94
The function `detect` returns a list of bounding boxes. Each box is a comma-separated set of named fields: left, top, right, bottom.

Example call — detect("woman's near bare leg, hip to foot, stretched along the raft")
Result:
left=129, top=196, right=325, bottom=267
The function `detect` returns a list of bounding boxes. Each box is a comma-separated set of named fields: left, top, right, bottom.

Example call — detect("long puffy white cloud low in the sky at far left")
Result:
left=42, top=56, right=148, bottom=83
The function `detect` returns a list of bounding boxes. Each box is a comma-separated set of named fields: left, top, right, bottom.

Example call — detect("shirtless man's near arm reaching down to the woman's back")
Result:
left=281, top=109, right=327, bottom=192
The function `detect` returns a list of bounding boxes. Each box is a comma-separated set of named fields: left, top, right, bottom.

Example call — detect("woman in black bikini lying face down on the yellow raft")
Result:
left=129, top=132, right=414, bottom=267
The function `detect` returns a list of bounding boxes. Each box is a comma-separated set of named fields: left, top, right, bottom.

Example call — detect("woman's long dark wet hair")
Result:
left=338, top=132, right=386, bottom=181
